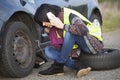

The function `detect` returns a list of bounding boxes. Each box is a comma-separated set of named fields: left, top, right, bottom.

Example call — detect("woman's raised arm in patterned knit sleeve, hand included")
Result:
left=50, top=14, right=89, bottom=36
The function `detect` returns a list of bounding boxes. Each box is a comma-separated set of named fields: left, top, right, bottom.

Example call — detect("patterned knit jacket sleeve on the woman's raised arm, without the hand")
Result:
left=64, top=16, right=89, bottom=36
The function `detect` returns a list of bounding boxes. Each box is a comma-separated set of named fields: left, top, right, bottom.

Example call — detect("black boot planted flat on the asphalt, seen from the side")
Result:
left=39, top=62, right=64, bottom=76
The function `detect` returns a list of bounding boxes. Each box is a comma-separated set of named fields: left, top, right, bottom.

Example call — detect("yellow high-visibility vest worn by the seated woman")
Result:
left=63, top=8, right=103, bottom=48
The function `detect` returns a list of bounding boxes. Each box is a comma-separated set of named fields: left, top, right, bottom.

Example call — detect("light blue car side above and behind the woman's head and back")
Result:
left=36, top=0, right=101, bottom=19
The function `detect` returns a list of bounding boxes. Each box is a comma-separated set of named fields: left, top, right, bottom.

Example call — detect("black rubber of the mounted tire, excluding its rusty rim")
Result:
left=0, top=22, right=35, bottom=77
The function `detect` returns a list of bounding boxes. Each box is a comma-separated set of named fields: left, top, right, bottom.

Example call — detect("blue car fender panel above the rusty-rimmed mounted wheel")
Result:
left=0, top=0, right=35, bottom=22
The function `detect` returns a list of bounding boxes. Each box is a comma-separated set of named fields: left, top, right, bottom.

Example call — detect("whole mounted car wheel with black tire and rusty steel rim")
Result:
left=0, top=22, right=35, bottom=77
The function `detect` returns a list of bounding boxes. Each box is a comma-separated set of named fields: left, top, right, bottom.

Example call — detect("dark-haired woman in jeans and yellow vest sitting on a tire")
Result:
left=35, top=4, right=103, bottom=77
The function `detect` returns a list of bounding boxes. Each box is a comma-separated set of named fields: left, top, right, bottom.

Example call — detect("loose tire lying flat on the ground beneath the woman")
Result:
left=79, top=49, right=120, bottom=70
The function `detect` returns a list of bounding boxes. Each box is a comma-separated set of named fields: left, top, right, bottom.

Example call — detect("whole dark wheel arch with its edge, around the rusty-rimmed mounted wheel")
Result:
left=0, top=11, right=40, bottom=51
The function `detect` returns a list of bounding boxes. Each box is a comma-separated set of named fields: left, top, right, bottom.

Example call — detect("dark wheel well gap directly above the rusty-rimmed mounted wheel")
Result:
left=1, top=11, right=38, bottom=42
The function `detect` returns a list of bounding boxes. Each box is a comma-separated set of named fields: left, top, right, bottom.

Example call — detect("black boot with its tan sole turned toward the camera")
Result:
left=73, top=61, right=91, bottom=78
